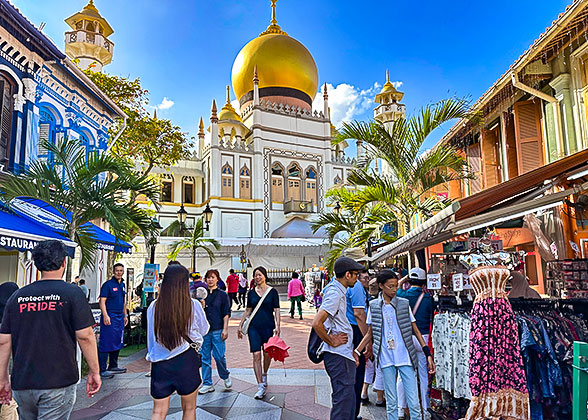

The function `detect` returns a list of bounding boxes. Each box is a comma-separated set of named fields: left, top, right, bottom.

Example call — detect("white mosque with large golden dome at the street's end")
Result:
left=66, top=0, right=404, bottom=272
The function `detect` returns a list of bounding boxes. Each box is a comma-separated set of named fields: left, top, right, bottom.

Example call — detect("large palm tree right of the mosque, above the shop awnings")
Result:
left=335, top=99, right=476, bottom=236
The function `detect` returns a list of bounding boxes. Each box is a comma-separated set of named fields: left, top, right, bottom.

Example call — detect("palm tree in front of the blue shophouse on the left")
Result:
left=0, top=138, right=159, bottom=281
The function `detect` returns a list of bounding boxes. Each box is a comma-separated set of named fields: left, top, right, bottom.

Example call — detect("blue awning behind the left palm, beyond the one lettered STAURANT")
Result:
left=4, top=197, right=132, bottom=254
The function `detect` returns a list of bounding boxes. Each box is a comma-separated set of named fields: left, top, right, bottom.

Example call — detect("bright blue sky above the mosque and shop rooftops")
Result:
left=12, top=0, right=571, bottom=151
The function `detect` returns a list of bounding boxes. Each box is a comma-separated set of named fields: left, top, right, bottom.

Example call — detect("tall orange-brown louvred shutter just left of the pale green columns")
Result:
left=514, top=99, right=544, bottom=174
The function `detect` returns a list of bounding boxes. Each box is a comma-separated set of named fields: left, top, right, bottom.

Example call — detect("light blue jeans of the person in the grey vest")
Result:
left=382, top=366, right=422, bottom=420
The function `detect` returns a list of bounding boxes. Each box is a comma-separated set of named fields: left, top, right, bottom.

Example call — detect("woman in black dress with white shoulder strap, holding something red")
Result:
left=237, top=267, right=280, bottom=399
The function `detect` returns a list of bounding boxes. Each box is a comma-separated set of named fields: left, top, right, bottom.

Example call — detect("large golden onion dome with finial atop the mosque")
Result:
left=232, top=1, right=318, bottom=104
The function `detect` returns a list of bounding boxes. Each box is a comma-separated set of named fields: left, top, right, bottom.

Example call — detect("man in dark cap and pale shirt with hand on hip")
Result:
left=312, top=257, right=364, bottom=420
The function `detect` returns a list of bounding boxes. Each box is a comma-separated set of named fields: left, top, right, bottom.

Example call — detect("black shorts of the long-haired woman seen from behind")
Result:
left=151, top=348, right=202, bottom=399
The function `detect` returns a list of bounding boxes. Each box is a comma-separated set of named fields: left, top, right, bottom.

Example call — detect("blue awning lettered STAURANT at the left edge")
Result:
left=0, top=209, right=77, bottom=257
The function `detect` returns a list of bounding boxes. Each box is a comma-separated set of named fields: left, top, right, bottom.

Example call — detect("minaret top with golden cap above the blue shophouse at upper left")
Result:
left=65, top=0, right=114, bottom=71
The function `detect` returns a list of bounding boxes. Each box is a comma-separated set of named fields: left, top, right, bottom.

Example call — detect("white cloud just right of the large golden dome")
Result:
left=312, top=82, right=402, bottom=127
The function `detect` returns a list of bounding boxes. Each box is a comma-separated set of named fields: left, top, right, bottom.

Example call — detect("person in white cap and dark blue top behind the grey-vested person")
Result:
left=396, top=267, right=433, bottom=419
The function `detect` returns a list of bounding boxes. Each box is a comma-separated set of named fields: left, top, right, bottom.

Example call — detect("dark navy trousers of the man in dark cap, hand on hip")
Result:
left=323, top=352, right=355, bottom=420
